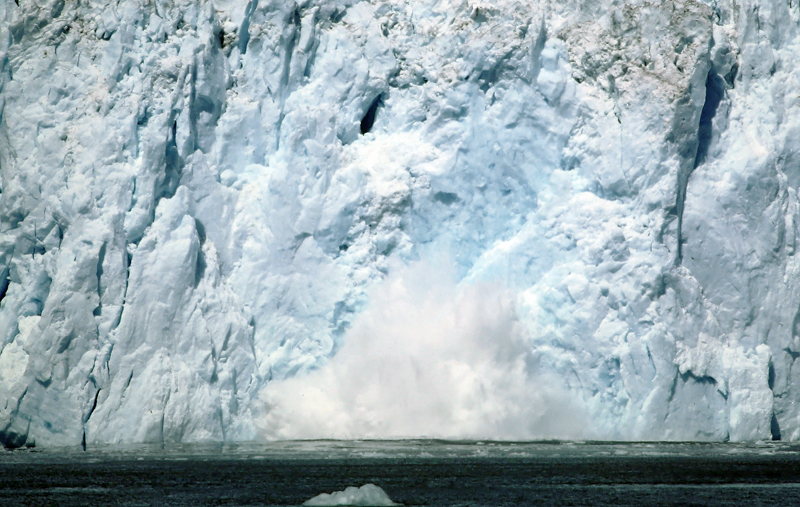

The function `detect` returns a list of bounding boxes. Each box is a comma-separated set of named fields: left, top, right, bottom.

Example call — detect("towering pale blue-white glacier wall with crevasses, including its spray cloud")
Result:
left=0, top=0, right=800, bottom=446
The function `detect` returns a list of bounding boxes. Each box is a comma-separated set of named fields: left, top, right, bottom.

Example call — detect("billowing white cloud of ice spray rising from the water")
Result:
left=260, top=262, right=585, bottom=439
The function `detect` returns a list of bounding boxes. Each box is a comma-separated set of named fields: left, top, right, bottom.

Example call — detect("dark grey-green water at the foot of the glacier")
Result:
left=0, top=440, right=800, bottom=507
